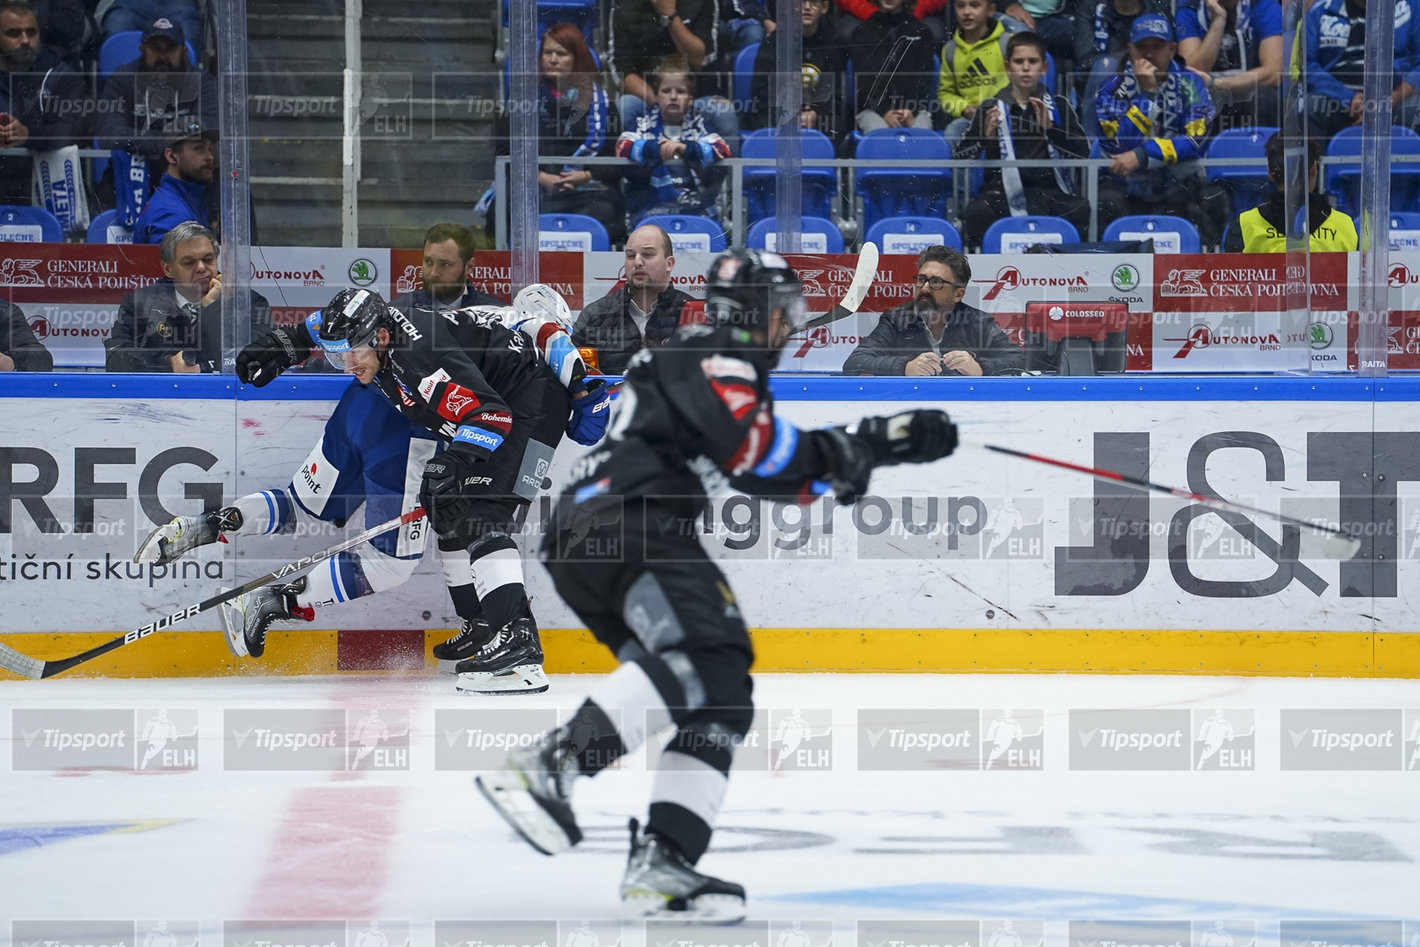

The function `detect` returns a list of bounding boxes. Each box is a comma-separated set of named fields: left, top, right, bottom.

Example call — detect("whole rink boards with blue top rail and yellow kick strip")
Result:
left=0, top=375, right=1420, bottom=676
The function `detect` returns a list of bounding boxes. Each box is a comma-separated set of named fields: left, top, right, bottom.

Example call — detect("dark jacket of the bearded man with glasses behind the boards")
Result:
left=843, top=302, right=1025, bottom=375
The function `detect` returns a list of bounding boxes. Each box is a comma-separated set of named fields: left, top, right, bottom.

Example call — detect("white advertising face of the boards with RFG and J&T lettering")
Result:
left=0, top=376, right=1420, bottom=632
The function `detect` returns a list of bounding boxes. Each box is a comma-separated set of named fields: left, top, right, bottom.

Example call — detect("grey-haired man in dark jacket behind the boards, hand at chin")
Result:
left=104, top=220, right=271, bottom=373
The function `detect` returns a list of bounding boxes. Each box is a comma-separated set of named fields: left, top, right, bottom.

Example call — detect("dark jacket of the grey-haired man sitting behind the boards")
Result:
left=104, top=278, right=271, bottom=372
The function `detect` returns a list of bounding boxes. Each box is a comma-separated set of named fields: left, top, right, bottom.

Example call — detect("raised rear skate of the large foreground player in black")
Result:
left=474, top=727, right=582, bottom=855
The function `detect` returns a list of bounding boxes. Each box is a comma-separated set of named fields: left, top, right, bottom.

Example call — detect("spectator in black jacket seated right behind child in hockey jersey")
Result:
left=608, top=0, right=740, bottom=149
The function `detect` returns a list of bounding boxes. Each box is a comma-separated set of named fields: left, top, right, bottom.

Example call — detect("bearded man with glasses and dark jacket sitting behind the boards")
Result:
left=843, top=247, right=1025, bottom=375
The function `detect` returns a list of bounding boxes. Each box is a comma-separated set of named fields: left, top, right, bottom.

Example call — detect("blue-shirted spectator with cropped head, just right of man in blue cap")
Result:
left=1173, top=0, right=1282, bottom=131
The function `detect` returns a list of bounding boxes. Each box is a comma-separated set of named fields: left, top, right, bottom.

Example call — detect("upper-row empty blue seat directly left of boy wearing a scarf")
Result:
left=853, top=128, right=951, bottom=229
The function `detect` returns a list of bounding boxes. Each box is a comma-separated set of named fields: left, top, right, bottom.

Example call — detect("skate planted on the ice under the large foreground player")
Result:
left=621, top=819, right=744, bottom=924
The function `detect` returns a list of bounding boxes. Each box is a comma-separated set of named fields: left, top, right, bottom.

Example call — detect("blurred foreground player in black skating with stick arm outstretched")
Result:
left=479, top=250, right=956, bottom=923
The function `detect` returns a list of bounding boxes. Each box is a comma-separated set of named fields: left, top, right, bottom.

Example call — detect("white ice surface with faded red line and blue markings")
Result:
left=0, top=674, right=1420, bottom=947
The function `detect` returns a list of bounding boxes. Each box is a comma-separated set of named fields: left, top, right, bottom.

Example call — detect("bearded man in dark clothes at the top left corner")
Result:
left=0, top=3, right=91, bottom=204
